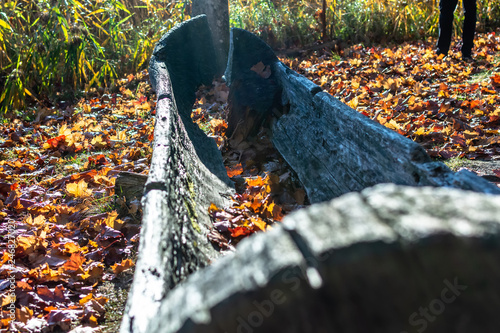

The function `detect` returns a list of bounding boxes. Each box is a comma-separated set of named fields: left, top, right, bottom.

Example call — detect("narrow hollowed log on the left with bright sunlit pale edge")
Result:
left=120, top=16, right=233, bottom=333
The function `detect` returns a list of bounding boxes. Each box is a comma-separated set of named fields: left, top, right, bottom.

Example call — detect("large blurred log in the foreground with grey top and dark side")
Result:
left=144, top=184, right=500, bottom=333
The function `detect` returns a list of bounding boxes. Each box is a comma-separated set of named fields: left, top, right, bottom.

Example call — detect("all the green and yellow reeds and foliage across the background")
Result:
left=0, top=0, right=500, bottom=114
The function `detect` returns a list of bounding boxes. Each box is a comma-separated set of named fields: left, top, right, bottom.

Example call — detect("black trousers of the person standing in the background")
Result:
left=437, top=0, right=477, bottom=57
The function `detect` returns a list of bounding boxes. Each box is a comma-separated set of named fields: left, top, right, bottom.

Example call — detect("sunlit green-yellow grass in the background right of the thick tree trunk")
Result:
left=229, top=0, right=500, bottom=47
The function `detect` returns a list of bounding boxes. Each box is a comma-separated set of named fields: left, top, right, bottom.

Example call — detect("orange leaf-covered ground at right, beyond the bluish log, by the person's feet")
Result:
left=284, top=32, right=500, bottom=160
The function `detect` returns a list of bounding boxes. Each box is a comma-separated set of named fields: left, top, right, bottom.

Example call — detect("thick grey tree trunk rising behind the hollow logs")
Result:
left=192, top=0, right=229, bottom=75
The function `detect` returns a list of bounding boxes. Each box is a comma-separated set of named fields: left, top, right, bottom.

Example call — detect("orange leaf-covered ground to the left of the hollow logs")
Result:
left=0, top=72, right=155, bottom=332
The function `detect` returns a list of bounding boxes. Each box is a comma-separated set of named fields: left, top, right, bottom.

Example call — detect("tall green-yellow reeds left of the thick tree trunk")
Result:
left=0, top=0, right=186, bottom=114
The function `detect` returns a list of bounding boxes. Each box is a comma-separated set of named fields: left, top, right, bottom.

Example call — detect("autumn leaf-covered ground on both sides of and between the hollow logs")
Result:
left=0, top=33, right=500, bottom=332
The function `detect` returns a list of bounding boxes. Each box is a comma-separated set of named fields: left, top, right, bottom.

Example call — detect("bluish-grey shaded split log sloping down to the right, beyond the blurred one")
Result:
left=226, top=29, right=500, bottom=203
